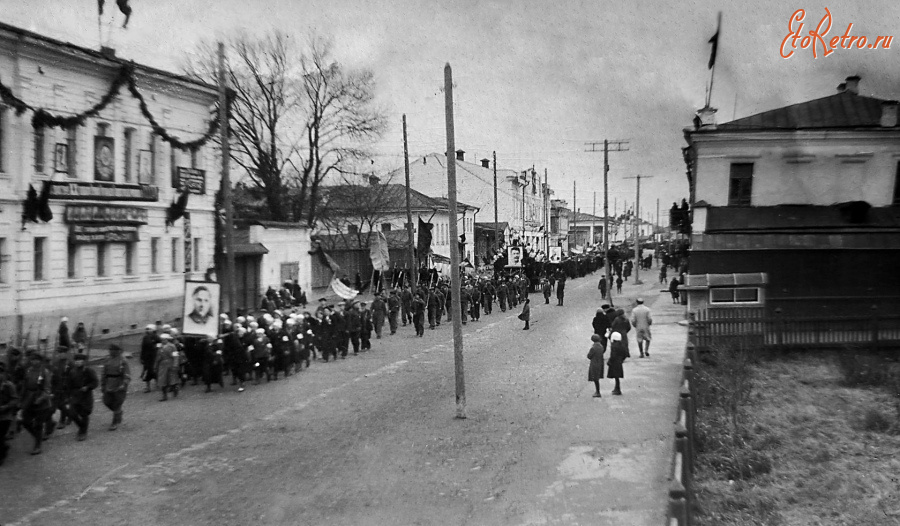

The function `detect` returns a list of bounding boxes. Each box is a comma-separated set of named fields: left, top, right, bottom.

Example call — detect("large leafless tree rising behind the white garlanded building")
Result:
left=183, top=31, right=385, bottom=226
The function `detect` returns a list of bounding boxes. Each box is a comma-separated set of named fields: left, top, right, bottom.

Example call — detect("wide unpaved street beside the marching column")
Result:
left=0, top=276, right=674, bottom=525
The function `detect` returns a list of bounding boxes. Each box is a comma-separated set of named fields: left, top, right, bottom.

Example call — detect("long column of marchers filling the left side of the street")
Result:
left=0, top=270, right=567, bottom=465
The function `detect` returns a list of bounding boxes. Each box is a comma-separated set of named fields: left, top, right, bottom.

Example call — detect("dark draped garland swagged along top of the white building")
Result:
left=0, top=62, right=234, bottom=151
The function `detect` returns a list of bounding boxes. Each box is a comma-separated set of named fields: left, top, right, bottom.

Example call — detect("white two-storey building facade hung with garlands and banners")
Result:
left=0, top=24, right=220, bottom=343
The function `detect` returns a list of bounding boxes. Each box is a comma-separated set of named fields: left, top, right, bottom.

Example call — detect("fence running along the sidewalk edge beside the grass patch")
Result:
left=666, top=338, right=697, bottom=526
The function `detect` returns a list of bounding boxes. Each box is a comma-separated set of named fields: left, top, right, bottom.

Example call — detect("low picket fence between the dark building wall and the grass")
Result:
left=691, top=309, right=900, bottom=349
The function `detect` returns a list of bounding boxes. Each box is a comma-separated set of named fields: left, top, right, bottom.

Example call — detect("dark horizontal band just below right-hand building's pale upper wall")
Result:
left=706, top=203, right=900, bottom=233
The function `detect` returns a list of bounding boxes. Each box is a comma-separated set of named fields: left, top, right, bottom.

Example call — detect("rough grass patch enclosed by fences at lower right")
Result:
left=693, top=351, right=900, bottom=526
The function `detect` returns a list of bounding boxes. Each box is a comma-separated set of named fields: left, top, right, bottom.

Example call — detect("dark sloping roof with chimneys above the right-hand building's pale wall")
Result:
left=717, top=90, right=886, bottom=131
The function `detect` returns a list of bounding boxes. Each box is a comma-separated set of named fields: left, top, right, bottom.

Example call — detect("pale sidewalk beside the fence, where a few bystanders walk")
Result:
left=525, top=271, right=687, bottom=526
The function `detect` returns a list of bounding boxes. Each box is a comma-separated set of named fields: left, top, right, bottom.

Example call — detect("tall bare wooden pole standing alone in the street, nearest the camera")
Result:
left=444, top=62, right=466, bottom=418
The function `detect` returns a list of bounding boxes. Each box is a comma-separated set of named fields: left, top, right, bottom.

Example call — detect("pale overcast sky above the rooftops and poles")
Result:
left=0, top=0, right=900, bottom=220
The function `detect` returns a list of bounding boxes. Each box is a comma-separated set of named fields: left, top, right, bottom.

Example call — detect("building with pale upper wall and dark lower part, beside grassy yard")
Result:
left=685, top=77, right=900, bottom=316
